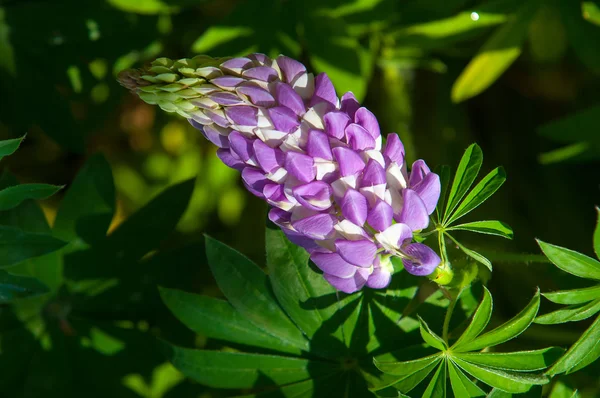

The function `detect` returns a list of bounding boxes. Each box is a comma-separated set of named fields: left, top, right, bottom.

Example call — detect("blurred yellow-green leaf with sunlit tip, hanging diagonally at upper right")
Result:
left=452, top=1, right=538, bottom=102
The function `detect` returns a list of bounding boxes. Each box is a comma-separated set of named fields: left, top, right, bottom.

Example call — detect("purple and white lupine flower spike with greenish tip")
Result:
left=120, top=54, right=440, bottom=293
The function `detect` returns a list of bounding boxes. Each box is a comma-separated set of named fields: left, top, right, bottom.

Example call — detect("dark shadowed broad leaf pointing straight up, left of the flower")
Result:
left=54, top=154, right=115, bottom=241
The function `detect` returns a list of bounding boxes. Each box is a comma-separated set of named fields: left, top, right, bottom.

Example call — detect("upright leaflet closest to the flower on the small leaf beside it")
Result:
left=443, top=144, right=483, bottom=225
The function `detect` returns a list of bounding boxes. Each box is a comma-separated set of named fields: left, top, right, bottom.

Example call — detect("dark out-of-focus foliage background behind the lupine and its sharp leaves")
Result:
left=0, top=0, right=600, bottom=397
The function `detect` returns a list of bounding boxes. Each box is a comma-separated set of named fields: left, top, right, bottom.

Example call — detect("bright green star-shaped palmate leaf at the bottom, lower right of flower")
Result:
left=374, top=287, right=552, bottom=397
